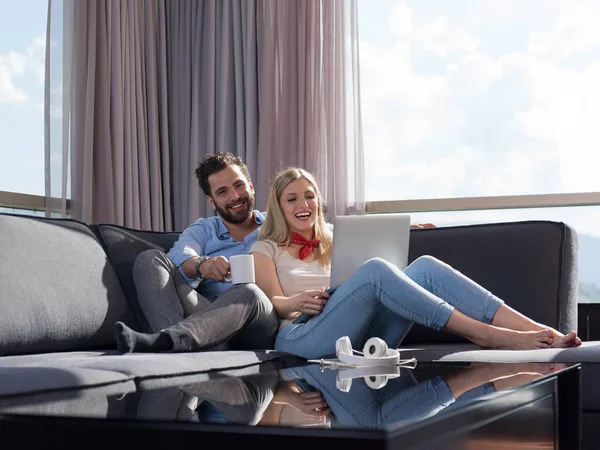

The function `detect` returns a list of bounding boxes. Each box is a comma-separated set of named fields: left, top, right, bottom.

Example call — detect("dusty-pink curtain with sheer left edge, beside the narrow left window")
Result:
left=45, top=0, right=173, bottom=231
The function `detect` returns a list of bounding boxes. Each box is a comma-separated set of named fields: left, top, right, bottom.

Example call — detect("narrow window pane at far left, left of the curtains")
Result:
left=0, top=1, right=47, bottom=195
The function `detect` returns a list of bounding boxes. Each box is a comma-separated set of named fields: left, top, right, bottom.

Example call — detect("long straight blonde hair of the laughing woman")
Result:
left=258, top=167, right=333, bottom=266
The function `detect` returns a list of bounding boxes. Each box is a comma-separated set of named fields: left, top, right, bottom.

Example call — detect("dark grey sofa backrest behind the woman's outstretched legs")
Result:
left=402, top=221, right=578, bottom=345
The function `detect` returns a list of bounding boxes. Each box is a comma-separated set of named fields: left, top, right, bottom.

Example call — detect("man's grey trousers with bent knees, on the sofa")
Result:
left=133, top=250, right=279, bottom=352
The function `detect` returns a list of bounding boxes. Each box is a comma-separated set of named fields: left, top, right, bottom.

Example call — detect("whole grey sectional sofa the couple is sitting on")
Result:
left=0, top=214, right=600, bottom=414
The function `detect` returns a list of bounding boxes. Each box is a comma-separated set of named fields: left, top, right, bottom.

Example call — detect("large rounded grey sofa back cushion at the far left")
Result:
left=0, top=214, right=132, bottom=355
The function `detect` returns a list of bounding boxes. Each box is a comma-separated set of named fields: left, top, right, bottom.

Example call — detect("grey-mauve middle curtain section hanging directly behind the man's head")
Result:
left=167, top=0, right=259, bottom=229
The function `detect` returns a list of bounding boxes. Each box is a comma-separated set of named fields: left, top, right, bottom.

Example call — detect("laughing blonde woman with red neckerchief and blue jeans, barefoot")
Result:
left=250, top=168, right=581, bottom=358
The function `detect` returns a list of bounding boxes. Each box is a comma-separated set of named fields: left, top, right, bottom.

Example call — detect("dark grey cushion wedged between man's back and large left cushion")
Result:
left=90, top=224, right=179, bottom=330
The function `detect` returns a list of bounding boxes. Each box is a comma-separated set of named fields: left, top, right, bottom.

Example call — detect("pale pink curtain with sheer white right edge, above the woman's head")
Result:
left=255, top=0, right=365, bottom=219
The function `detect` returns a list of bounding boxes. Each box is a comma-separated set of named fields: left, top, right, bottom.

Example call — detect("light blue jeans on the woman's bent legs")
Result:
left=275, top=256, right=503, bottom=358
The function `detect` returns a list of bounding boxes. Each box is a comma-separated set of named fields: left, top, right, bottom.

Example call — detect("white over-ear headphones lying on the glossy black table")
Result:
left=335, top=336, right=400, bottom=367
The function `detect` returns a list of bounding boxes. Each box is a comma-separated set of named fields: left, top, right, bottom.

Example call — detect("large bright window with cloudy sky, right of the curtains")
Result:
left=359, top=0, right=600, bottom=302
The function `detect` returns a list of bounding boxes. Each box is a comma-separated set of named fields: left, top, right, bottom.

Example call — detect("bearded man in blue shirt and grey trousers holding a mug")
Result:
left=115, top=153, right=279, bottom=353
